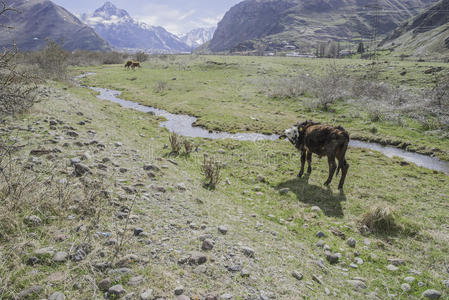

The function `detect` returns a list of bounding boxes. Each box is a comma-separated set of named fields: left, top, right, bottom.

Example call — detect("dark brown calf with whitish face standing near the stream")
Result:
left=281, top=121, right=349, bottom=189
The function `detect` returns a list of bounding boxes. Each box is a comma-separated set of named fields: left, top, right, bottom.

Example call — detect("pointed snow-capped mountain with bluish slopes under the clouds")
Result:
left=81, top=1, right=190, bottom=52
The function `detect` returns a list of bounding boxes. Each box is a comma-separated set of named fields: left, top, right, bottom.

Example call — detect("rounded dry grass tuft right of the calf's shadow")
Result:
left=359, top=205, right=398, bottom=233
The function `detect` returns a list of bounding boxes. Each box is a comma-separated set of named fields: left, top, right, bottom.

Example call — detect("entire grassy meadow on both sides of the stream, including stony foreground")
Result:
left=0, top=56, right=449, bottom=299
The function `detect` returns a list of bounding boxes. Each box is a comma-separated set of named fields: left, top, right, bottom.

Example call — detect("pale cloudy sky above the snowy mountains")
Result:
left=53, top=0, right=242, bottom=34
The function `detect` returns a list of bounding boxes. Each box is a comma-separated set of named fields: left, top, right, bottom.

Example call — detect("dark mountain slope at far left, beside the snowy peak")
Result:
left=0, top=0, right=110, bottom=51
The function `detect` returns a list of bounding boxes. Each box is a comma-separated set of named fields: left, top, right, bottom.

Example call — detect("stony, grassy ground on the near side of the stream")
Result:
left=0, top=57, right=449, bottom=299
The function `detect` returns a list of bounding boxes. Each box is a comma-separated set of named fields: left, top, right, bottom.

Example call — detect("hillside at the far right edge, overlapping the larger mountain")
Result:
left=382, top=0, right=449, bottom=57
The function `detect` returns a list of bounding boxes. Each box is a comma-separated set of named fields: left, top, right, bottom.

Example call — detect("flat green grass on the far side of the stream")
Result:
left=75, top=56, right=449, bottom=159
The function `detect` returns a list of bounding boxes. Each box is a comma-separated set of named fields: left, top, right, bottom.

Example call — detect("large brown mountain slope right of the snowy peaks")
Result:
left=208, top=0, right=436, bottom=52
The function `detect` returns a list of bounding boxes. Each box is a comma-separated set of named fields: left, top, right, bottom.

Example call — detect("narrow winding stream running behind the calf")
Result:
left=76, top=73, right=449, bottom=175
